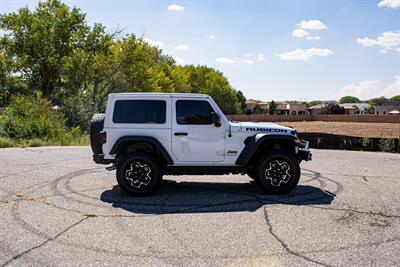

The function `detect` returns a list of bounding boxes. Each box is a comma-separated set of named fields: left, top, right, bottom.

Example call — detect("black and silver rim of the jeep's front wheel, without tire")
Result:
left=265, top=159, right=292, bottom=186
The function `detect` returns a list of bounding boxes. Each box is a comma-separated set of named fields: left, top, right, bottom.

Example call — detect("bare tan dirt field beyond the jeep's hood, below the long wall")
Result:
left=277, top=121, right=400, bottom=138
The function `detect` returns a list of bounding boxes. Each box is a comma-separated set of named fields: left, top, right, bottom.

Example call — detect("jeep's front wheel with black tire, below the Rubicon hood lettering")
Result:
left=255, top=150, right=300, bottom=195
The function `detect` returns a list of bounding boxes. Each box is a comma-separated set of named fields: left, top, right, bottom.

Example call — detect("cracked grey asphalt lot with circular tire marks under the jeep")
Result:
left=0, top=147, right=400, bottom=267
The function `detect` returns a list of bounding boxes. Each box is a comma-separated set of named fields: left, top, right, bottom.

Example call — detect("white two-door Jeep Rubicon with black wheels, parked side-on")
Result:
left=90, top=93, right=311, bottom=195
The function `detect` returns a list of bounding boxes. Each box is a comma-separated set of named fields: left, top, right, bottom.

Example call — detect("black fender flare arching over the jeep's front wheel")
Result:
left=236, top=133, right=297, bottom=165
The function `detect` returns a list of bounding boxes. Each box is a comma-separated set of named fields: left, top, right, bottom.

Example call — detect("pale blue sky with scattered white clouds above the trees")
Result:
left=0, top=0, right=400, bottom=101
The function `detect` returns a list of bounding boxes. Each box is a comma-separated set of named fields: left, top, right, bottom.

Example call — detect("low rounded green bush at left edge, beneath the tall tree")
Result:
left=0, top=95, right=68, bottom=140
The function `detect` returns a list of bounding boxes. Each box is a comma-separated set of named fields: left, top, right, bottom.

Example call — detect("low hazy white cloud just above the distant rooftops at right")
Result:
left=340, top=80, right=381, bottom=99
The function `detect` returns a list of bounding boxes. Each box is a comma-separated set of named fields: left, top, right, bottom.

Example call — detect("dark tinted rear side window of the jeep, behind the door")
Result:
left=113, top=100, right=167, bottom=124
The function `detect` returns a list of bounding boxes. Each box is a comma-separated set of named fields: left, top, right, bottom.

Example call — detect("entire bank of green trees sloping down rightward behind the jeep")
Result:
left=0, top=0, right=246, bottom=124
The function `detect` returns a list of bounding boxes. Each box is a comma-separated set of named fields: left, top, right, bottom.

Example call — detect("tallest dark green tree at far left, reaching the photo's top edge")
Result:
left=0, top=0, right=110, bottom=101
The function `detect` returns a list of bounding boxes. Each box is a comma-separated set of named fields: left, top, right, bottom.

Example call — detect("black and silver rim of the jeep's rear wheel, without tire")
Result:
left=125, top=160, right=152, bottom=189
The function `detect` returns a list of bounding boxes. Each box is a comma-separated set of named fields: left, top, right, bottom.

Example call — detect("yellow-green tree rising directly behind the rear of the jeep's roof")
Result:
left=89, top=34, right=180, bottom=111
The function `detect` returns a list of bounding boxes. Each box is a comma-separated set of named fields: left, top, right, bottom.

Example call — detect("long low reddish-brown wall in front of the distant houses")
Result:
left=228, top=114, right=400, bottom=123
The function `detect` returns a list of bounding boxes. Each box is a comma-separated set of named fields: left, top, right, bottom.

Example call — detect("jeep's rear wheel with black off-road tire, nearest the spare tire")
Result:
left=117, top=152, right=163, bottom=196
